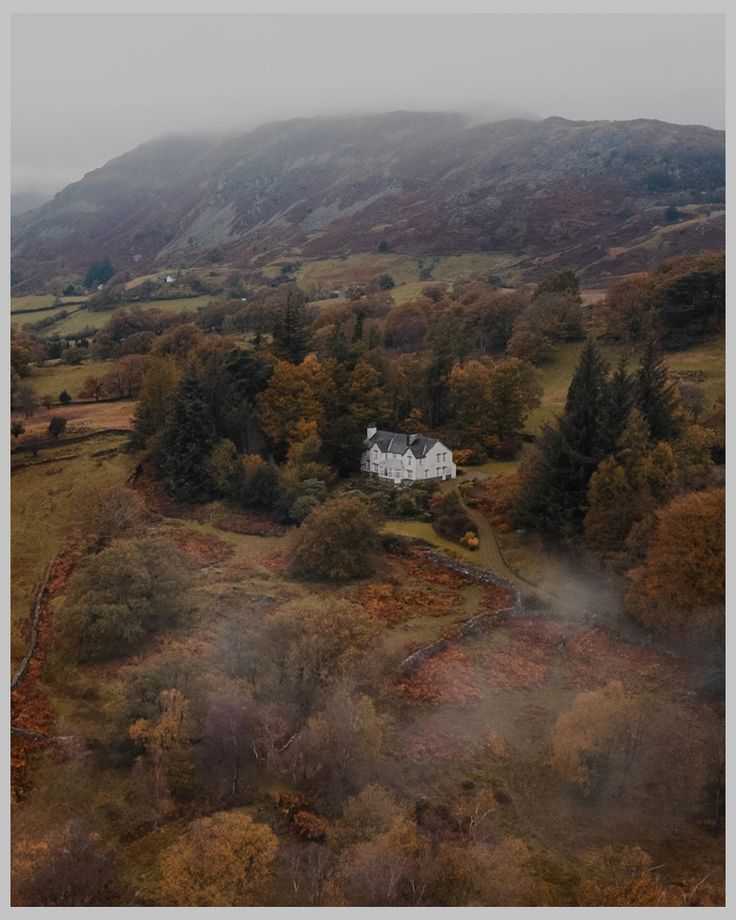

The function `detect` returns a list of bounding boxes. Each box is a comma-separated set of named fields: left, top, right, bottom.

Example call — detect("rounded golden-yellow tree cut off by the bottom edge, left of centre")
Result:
left=156, top=811, right=278, bottom=907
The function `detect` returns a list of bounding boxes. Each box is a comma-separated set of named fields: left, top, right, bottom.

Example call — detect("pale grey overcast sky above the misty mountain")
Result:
left=11, top=14, right=725, bottom=192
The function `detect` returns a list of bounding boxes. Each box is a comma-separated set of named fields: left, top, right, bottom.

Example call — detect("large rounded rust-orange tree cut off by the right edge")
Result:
left=628, top=489, right=725, bottom=642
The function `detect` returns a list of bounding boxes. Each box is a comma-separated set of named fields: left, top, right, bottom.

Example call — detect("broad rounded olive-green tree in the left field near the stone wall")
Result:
left=59, top=537, right=190, bottom=661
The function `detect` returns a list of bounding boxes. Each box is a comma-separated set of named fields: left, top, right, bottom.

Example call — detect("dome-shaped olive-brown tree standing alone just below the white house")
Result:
left=289, top=497, right=378, bottom=580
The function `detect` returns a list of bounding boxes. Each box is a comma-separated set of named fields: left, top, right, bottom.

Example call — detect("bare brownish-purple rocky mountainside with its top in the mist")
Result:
left=12, top=112, right=724, bottom=293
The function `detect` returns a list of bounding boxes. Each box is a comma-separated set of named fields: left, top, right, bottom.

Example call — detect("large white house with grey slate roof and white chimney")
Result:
left=360, top=425, right=457, bottom=485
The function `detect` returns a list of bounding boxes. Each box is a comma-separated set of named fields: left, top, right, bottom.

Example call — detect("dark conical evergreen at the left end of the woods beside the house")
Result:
left=157, top=367, right=216, bottom=501
